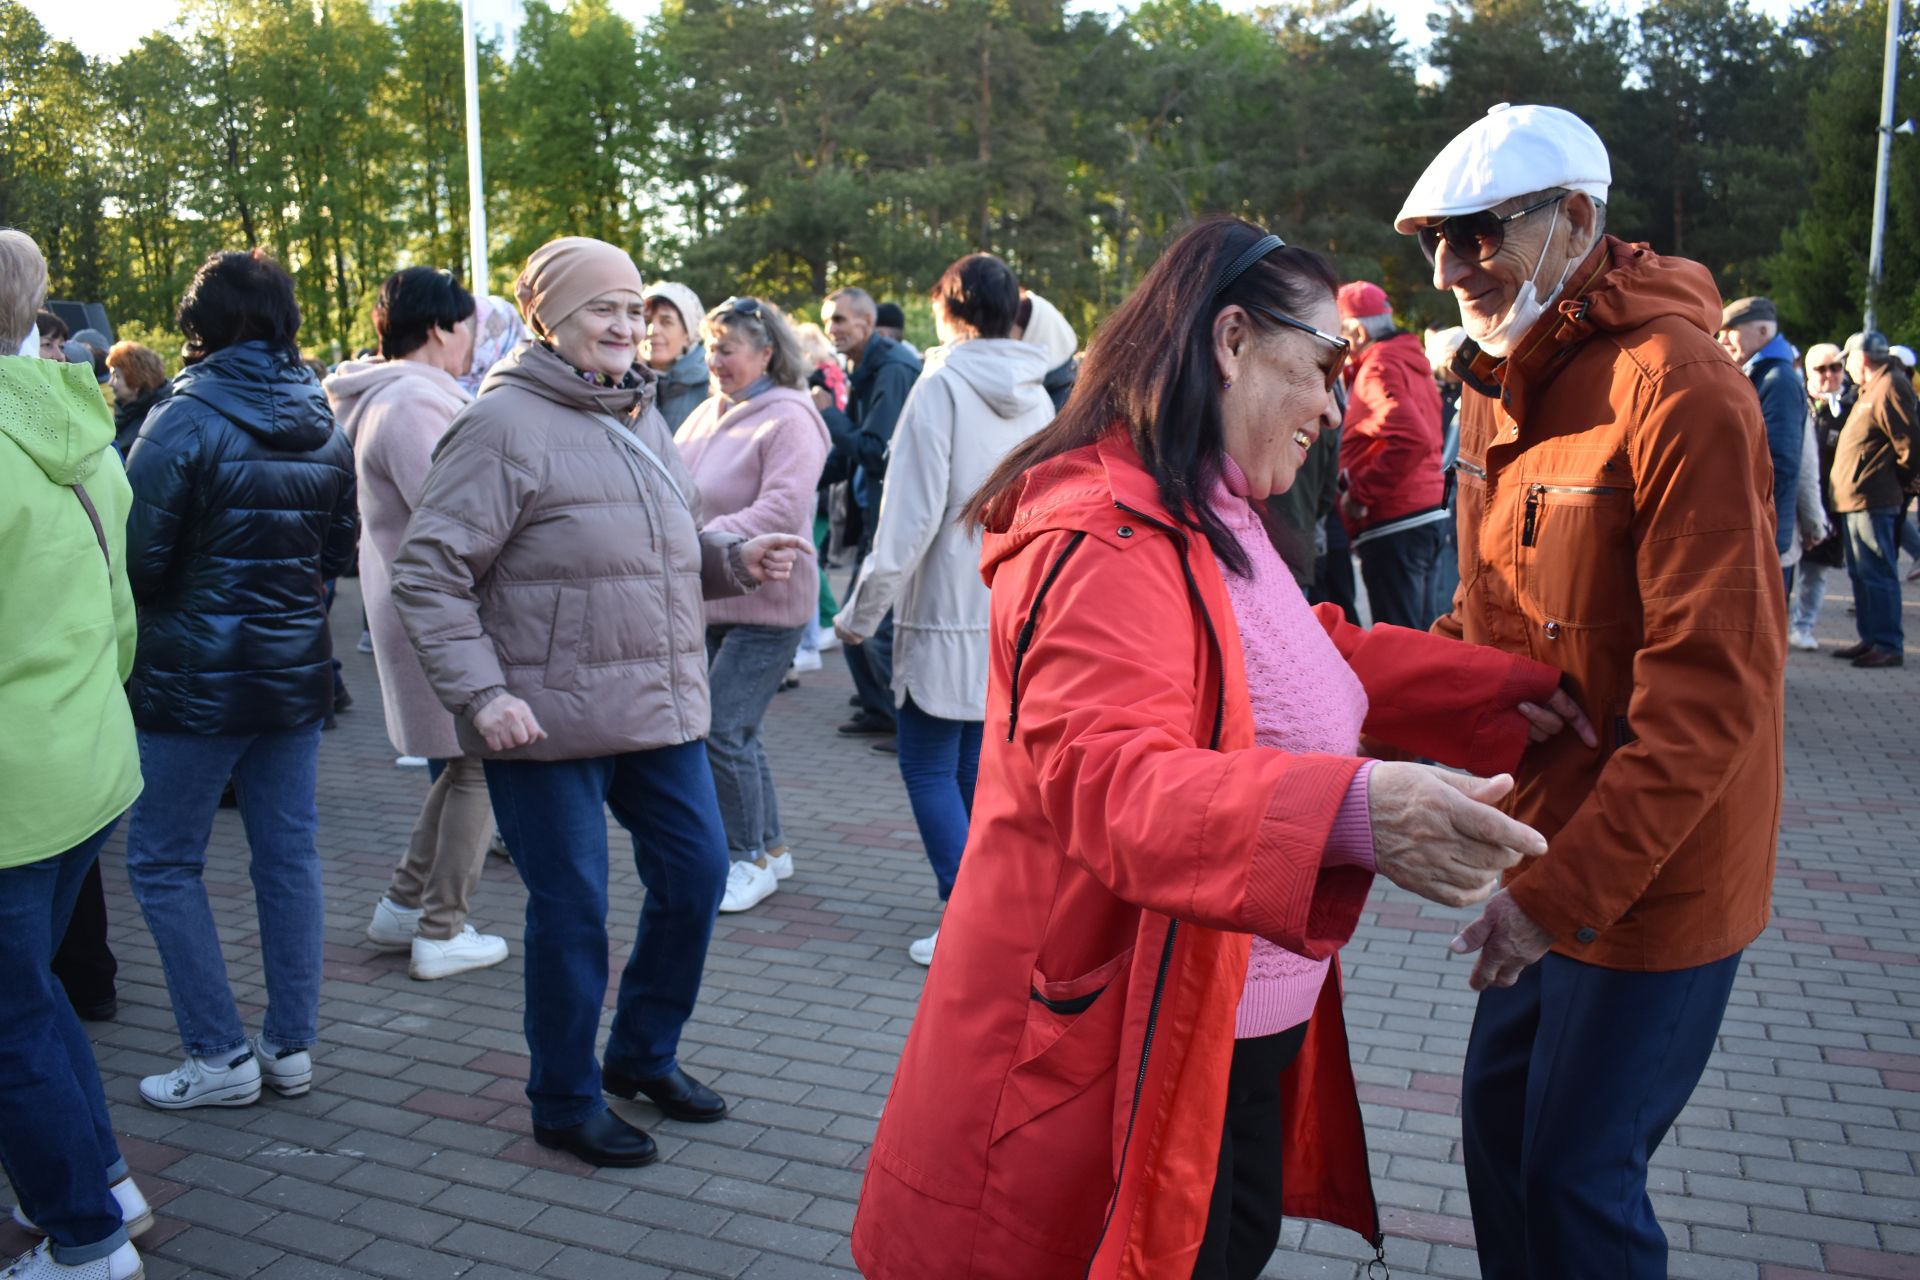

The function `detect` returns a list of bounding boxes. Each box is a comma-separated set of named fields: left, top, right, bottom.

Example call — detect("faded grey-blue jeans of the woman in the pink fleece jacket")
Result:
left=707, top=626, right=803, bottom=862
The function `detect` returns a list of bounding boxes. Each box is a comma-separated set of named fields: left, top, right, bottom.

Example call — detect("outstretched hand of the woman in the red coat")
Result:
left=1367, top=762, right=1548, bottom=906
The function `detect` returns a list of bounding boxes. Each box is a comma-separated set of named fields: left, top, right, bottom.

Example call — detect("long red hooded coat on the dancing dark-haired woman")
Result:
left=852, top=432, right=1559, bottom=1280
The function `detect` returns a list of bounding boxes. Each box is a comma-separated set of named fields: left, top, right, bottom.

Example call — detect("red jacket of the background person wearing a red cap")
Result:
left=1340, top=334, right=1446, bottom=533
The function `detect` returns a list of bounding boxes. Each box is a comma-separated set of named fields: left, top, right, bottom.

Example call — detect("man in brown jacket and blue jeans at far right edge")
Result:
left=1832, top=330, right=1920, bottom=668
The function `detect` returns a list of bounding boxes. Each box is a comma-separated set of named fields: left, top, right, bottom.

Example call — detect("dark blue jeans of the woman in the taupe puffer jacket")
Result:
left=486, top=743, right=728, bottom=1128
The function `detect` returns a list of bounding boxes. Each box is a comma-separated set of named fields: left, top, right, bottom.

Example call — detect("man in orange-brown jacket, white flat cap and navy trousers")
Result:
left=1396, top=106, right=1786, bottom=1280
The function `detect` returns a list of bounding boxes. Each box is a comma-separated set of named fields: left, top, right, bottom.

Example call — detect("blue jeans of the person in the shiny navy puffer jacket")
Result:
left=127, top=723, right=326, bottom=1057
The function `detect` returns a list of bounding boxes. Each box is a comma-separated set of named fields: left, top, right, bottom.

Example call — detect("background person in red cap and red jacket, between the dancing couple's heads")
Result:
left=1338, top=280, right=1450, bottom=631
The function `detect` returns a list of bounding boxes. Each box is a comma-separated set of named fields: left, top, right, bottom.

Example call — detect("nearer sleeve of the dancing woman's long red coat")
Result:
left=996, top=533, right=1373, bottom=958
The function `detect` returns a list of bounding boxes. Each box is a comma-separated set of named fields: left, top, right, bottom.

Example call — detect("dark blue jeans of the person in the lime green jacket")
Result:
left=0, top=819, right=127, bottom=1267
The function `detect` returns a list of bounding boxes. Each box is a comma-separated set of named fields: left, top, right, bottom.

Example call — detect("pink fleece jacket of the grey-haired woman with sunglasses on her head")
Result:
left=674, top=386, right=828, bottom=628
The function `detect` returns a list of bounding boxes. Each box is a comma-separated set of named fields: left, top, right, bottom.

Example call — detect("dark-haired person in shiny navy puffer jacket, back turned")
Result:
left=127, top=249, right=355, bottom=1111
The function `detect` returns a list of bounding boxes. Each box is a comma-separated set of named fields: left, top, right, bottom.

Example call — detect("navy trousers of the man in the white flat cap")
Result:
left=1461, top=952, right=1740, bottom=1280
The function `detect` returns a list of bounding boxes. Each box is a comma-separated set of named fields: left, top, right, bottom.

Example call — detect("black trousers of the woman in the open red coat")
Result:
left=1192, top=1023, right=1308, bottom=1280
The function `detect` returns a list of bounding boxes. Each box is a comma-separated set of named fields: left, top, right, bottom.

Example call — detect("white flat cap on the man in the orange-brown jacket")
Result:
left=1394, top=102, right=1613, bottom=236
